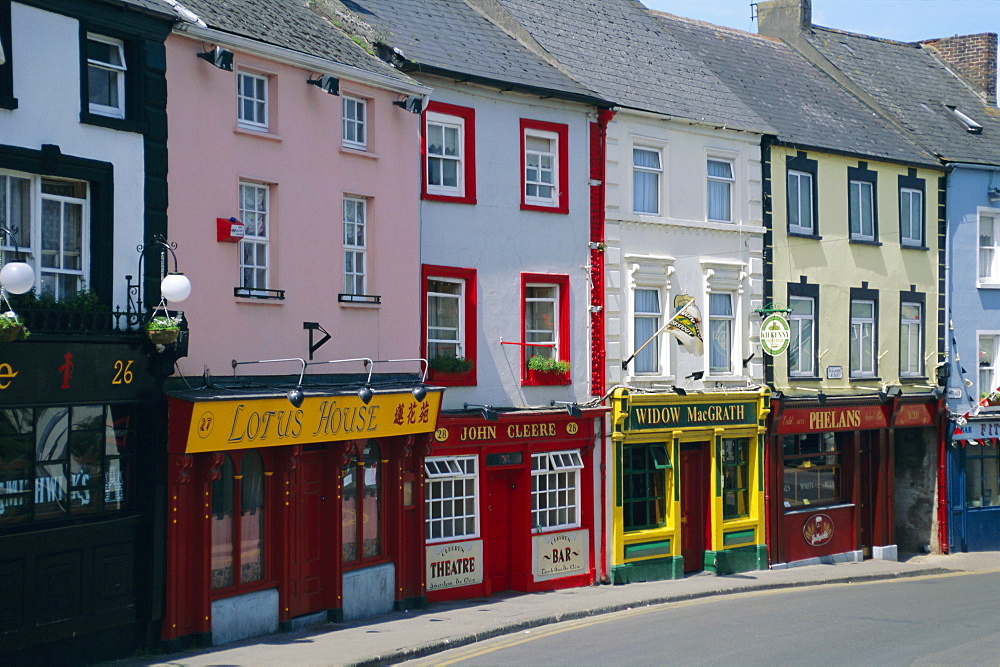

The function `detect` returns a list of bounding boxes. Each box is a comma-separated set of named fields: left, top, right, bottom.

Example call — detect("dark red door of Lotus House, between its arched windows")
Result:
left=289, top=450, right=330, bottom=618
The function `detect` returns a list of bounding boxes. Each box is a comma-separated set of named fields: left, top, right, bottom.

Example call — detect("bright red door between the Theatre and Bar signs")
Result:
left=483, top=468, right=517, bottom=595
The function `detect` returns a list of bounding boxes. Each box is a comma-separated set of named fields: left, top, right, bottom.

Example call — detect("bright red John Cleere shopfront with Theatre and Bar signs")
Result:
left=424, top=409, right=604, bottom=602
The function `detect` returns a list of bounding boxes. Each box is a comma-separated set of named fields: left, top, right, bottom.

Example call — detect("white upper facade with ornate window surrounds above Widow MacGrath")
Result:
left=605, top=109, right=764, bottom=390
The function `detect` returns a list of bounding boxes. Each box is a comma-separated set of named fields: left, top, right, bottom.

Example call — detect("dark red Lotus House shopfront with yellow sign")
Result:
left=162, top=388, right=441, bottom=649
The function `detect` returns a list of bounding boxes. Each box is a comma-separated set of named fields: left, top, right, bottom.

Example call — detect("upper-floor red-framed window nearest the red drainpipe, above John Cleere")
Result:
left=521, top=118, right=569, bottom=213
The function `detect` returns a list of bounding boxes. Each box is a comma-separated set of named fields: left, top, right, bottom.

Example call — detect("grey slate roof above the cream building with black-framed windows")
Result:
left=651, top=12, right=939, bottom=166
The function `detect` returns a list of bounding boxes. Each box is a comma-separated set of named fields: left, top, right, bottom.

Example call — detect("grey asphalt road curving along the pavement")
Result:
left=406, top=572, right=1000, bottom=666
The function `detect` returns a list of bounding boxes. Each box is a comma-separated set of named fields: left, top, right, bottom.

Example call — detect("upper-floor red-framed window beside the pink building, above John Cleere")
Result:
left=421, top=101, right=476, bottom=204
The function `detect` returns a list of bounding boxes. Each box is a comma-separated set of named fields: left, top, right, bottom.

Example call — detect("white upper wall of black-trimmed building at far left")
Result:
left=0, top=2, right=145, bottom=309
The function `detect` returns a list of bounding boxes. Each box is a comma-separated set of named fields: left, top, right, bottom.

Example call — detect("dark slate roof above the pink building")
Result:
left=174, top=0, right=409, bottom=81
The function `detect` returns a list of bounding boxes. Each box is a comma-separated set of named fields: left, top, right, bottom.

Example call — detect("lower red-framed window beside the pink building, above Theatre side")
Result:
left=421, top=264, right=476, bottom=386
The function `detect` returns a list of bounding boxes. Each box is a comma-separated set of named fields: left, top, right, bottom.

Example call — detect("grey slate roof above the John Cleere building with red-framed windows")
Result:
left=336, top=0, right=598, bottom=102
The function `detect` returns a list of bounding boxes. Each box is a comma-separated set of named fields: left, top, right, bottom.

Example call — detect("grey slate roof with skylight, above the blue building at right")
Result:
left=803, top=26, right=1000, bottom=164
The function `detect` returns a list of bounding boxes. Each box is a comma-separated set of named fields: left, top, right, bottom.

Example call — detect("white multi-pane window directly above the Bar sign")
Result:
left=531, top=450, right=583, bottom=531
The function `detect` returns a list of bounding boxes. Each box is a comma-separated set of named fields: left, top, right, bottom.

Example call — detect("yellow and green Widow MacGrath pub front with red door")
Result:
left=611, top=387, right=770, bottom=584
